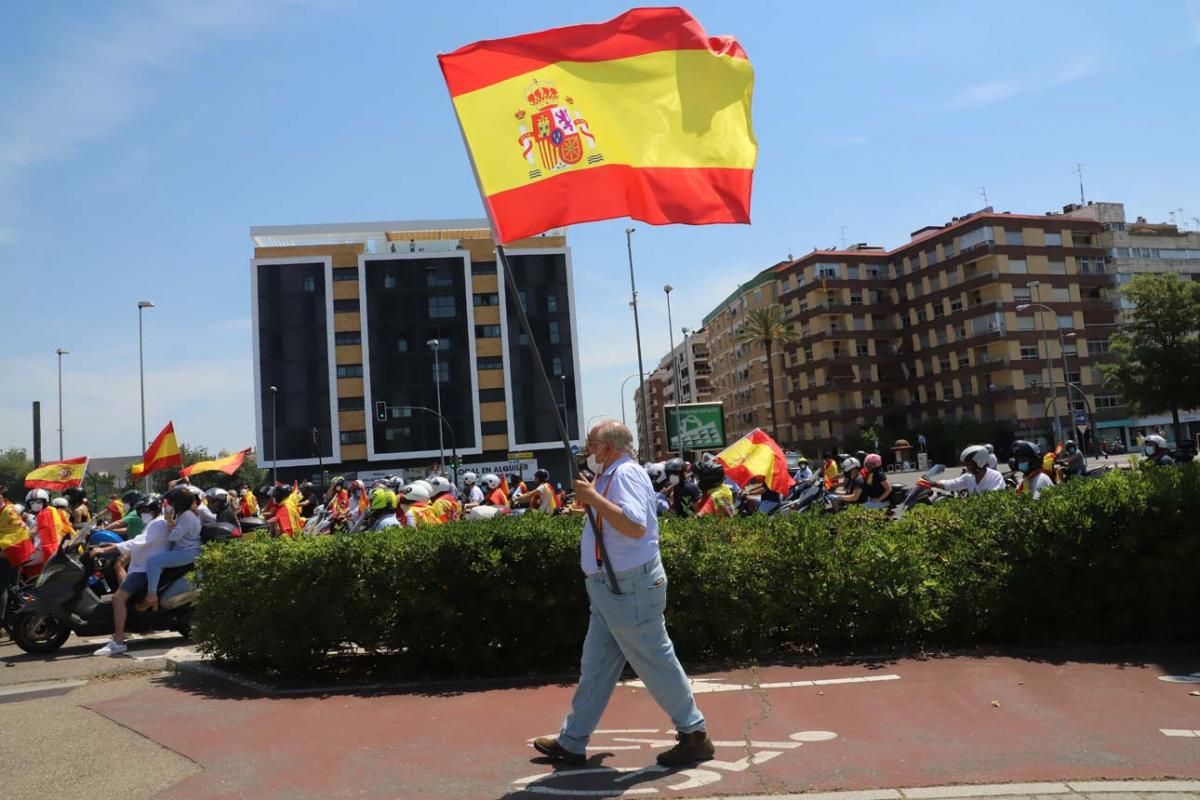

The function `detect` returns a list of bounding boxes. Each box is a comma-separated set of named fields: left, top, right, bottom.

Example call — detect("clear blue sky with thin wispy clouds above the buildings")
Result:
left=0, top=0, right=1200, bottom=457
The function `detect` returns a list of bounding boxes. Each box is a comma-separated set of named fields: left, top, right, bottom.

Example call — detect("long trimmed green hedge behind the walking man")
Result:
left=193, top=464, right=1200, bottom=678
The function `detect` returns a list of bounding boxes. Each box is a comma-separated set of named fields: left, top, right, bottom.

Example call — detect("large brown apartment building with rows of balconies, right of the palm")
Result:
left=775, top=207, right=1126, bottom=450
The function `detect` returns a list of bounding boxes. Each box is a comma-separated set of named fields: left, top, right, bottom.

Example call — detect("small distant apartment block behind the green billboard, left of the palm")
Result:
left=634, top=329, right=716, bottom=461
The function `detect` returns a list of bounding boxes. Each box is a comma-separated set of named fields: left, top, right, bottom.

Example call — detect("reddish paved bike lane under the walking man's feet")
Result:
left=92, top=649, right=1200, bottom=800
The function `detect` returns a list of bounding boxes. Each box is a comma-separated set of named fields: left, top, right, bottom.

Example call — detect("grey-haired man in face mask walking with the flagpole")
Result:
left=533, top=421, right=713, bottom=768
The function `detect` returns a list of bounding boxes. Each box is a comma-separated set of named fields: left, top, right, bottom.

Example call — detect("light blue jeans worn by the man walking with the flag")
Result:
left=558, top=555, right=704, bottom=753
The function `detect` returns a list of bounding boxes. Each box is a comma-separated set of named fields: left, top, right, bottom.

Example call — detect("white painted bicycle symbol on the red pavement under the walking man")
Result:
left=512, top=728, right=838, bottom=798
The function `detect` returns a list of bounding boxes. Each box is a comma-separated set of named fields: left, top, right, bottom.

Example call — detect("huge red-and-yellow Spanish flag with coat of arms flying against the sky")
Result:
left=438, top=8, right=757, bottom=242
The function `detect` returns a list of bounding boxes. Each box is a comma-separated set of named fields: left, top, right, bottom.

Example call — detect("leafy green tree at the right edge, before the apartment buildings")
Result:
left=1100, top=272, right=1200, bottom=443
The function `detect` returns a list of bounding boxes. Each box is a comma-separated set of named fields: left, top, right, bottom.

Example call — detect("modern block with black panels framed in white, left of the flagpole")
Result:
left=251, top=219, right=581, bottom=481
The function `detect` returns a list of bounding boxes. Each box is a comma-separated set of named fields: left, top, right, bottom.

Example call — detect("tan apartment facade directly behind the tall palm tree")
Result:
left=704, top=265, right=798, bottom=447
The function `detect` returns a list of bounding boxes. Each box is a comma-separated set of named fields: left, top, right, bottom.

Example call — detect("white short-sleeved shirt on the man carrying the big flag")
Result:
left=580, top=456, right=659, bottom=575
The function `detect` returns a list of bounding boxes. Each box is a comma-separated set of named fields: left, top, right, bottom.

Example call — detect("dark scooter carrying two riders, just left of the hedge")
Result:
left=6, top=523, right=235, bottom=655
